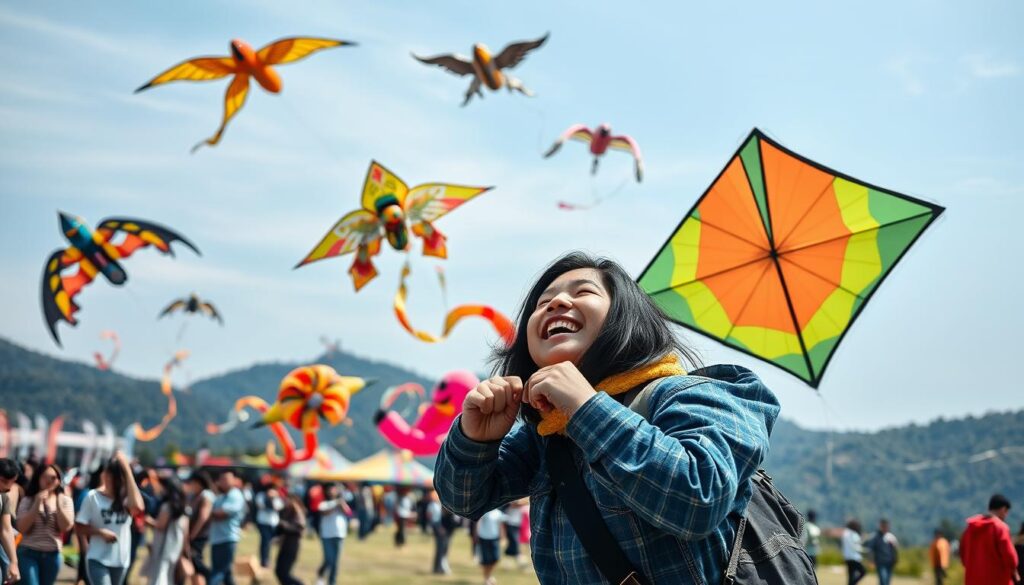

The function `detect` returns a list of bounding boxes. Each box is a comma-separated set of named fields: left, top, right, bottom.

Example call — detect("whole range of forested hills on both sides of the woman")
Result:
left=0, top=339, right=1024, bottom=543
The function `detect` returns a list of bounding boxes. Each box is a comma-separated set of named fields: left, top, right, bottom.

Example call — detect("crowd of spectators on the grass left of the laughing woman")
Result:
left=0, top=454, right=529, bottom=585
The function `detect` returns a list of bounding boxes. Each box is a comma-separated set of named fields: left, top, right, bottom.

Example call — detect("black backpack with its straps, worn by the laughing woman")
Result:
left=548, top=374, right=818, bottom=585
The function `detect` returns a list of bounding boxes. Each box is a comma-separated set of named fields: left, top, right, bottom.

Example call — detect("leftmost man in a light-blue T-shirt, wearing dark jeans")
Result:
left=205, top=470, right=246, bottom=585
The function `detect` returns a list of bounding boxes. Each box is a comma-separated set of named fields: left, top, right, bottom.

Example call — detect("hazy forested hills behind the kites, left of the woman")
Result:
left=0, top=339, right=433, bottom=459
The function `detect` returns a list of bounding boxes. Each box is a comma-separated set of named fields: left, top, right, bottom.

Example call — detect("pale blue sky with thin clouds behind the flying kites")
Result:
left=0, top=1, right=1024, bottom=428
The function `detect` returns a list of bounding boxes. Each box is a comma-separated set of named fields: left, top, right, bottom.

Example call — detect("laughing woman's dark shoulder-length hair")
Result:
left=490, top=252, right=699, bottom=424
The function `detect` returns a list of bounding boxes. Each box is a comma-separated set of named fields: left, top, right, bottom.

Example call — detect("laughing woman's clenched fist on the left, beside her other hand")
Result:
left=462, top=376, right=522, bottom=443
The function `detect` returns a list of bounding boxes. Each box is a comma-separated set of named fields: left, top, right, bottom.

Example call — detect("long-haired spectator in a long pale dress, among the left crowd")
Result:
left=143, top=475, right=188, bottom=585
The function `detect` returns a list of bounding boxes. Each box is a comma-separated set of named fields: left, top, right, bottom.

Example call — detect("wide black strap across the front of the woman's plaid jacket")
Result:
left=545, top=435, right=646, bottom=585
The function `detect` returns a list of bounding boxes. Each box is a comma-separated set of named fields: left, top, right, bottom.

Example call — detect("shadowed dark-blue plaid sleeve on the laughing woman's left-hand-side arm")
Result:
left=434, top=416, right=539, bottom=519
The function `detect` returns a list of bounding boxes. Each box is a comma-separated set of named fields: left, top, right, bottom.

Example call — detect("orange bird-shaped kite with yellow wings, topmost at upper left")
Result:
left=135, top=37, right=355, bottom=153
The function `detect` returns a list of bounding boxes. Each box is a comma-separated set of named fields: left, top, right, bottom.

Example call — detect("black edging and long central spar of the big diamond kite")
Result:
left=636, top=128, right=945, bottom=389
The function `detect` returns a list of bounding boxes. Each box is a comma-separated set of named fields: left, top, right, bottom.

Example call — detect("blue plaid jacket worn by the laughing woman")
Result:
left=434, top=366, right=779, bottom=585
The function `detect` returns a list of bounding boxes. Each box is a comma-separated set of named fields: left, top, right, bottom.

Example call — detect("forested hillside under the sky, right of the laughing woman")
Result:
left=765, top=411, right=1024, bottom=544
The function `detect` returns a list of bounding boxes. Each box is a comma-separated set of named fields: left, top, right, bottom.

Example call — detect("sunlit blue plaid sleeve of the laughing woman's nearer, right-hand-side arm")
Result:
left=566, top=376, right=778, bottom=540
